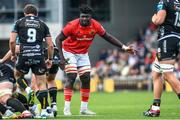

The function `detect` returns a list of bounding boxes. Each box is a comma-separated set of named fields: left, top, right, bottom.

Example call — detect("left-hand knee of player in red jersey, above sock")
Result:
left=65, top=73, right=77, bottom=89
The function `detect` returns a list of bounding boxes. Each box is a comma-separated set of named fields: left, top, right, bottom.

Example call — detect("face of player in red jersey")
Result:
left=80, top=13, right=91, bottom=26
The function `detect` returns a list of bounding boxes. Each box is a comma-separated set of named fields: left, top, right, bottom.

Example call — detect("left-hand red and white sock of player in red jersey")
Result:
left=64, top=88, right=73, bottom=108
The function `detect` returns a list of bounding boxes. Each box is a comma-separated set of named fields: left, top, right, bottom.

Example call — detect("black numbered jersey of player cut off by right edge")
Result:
left=157, top=0, right=180, bottom=36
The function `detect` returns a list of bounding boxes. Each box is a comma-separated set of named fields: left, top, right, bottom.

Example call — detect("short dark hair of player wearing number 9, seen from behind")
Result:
left=24, top=4, right=38, bottom=15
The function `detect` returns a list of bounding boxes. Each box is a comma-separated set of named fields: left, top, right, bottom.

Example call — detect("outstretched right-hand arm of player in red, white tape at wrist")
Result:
left=102, top=32, right=137, bottom=54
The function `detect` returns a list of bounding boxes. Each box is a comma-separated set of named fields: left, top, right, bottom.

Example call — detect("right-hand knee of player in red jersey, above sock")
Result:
left=80, top=72, right=90, bottom=89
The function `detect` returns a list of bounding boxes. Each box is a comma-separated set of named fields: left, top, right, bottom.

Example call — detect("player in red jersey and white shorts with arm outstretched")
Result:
left=56, top=5, right=135, bottom=115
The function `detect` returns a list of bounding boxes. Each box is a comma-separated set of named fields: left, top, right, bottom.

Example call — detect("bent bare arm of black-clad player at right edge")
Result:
left=152, top=10, right=166, bottom=25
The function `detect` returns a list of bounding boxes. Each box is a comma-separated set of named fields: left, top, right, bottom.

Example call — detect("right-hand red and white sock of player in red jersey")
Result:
left=80, top=89, right=90, bottom=110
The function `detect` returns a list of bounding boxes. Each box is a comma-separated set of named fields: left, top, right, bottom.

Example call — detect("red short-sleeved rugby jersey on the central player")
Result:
left=62, top=19, right=106, bottom=54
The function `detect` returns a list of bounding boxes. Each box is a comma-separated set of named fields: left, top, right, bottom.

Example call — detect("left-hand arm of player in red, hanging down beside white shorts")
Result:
left=56, top=32, right=67, bottom=70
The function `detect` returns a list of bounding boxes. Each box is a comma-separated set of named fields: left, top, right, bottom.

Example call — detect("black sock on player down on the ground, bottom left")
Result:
left=6, top=98, right=26, bottom=113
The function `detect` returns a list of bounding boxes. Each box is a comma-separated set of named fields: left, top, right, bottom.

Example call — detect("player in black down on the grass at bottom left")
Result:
left=0, top=61, right=32, bottom=118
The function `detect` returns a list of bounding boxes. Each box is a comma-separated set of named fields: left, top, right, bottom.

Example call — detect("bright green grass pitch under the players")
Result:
left=50, top=91, right=180, bottom=120
